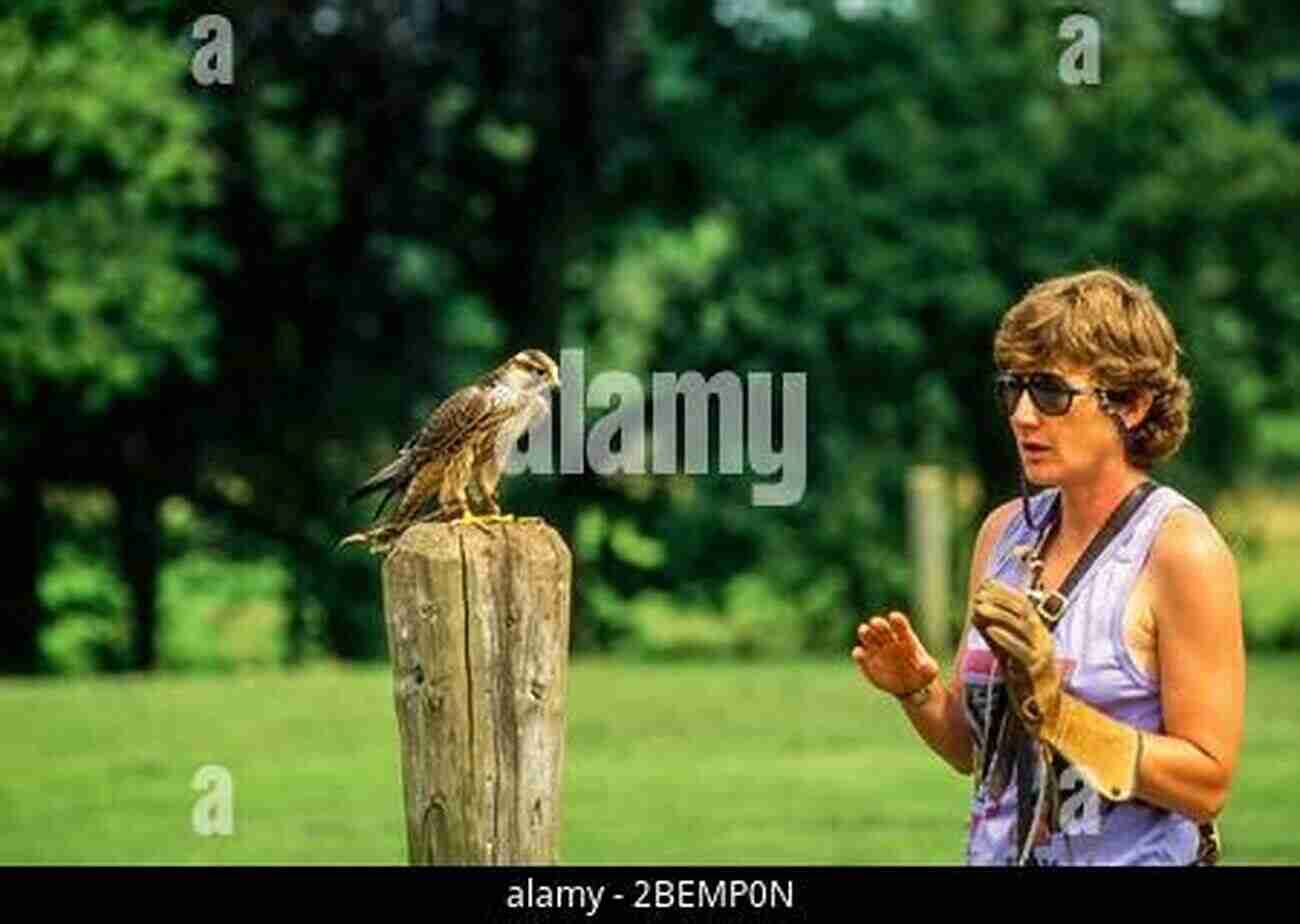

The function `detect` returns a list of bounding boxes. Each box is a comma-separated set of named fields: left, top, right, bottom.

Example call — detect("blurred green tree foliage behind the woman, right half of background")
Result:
left=561, top=1, right=1300, bottom=647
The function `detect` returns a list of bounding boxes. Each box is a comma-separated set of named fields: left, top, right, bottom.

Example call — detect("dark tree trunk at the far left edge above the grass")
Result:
left=0, top=472, right=46, bottom=673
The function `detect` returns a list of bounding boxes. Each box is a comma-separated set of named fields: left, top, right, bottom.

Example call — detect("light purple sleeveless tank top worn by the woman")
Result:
left=959, top=486, right=1200, bottom=866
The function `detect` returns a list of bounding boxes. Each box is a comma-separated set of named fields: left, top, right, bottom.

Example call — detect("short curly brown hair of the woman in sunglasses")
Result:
left=993, top=269, right=1192, bottom=470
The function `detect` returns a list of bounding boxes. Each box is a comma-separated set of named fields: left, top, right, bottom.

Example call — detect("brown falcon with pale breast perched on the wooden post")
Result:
left=339, top=350, right=560, bottom=551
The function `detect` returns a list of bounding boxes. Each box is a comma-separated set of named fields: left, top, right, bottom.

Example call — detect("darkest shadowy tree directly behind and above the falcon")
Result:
left=175, top=1, right=650, bottom=656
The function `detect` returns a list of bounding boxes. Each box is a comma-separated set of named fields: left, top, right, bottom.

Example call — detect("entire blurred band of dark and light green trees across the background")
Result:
left=0, top=0, right=1300, bottom=669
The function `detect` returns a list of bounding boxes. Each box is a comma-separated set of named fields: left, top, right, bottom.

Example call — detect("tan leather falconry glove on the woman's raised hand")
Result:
left=971, top=580, right=1141, bottom=802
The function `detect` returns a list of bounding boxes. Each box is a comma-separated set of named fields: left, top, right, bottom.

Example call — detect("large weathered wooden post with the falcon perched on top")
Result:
left=384, top=522, right=572, bottom=866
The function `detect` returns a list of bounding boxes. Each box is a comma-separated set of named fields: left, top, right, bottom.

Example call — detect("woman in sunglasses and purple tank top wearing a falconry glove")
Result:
left=853, top=270, right=1245, bottom=866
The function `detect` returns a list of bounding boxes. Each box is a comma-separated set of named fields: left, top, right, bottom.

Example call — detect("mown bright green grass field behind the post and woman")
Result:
left=0, top=656, right=1300, bottom=866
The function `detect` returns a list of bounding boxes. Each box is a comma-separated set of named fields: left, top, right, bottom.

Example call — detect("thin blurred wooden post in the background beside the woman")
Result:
left=907, top=465, right=952, bottom=654
